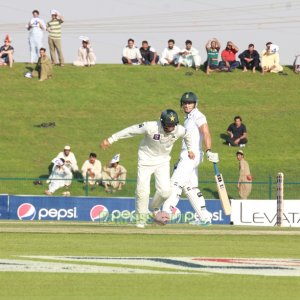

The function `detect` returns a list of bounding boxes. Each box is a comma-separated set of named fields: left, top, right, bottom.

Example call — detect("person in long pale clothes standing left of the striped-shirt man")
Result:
left=26, top=9, right=46, bottom=64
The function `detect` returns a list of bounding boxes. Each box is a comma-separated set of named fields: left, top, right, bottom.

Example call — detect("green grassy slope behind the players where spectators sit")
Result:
left=0, top=64, right=300, bottom=194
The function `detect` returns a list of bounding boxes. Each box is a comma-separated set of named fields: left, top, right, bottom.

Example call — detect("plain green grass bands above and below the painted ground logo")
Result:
left=0, top=223, right=300, bottom=300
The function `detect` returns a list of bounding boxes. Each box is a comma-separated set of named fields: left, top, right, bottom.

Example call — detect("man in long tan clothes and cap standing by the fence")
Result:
left=236, top=150, right=252, bottom=199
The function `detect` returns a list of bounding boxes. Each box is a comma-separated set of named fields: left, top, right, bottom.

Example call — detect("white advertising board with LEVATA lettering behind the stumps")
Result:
left=231, top=200, right=300, bottom=227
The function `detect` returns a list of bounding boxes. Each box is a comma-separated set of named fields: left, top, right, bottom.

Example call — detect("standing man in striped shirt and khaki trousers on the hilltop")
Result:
left=47, top=9, right=64, bottom=67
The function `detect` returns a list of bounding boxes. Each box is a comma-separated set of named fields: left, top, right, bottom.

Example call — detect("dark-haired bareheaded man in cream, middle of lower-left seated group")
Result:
left=81, top=153, right=102, bottom=185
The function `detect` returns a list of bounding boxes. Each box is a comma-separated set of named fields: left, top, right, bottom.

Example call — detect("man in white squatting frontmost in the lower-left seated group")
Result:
left=45, top=158, right=72, bottom=196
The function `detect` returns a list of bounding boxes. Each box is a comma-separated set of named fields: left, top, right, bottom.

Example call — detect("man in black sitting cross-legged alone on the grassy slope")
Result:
left=227, top=116, right=248, bottom=147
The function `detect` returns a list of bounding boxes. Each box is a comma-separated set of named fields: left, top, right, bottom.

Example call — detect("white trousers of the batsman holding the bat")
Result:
left=163, top=151, right=202, bottom=213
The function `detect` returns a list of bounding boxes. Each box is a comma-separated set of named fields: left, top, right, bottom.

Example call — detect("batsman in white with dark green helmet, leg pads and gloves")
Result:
left=163, top=92, right=219, bottom=225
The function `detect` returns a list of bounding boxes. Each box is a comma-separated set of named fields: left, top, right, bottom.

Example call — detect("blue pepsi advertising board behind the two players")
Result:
left=7, top=196, right=230, bottom=224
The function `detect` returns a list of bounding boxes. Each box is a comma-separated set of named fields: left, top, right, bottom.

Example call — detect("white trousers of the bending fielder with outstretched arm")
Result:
left=135, top=161, right=171, bottom=215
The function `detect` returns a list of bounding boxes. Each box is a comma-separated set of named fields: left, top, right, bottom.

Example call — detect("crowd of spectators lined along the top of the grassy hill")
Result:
left=0, top=9, right=300, bottom=77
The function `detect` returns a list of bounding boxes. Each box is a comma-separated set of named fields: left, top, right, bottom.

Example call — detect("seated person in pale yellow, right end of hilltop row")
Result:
left=260, top=42, right=283, bottom=74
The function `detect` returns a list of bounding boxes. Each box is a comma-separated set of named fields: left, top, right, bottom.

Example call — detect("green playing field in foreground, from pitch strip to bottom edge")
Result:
left=0, top=222, right=300, bottom=300
